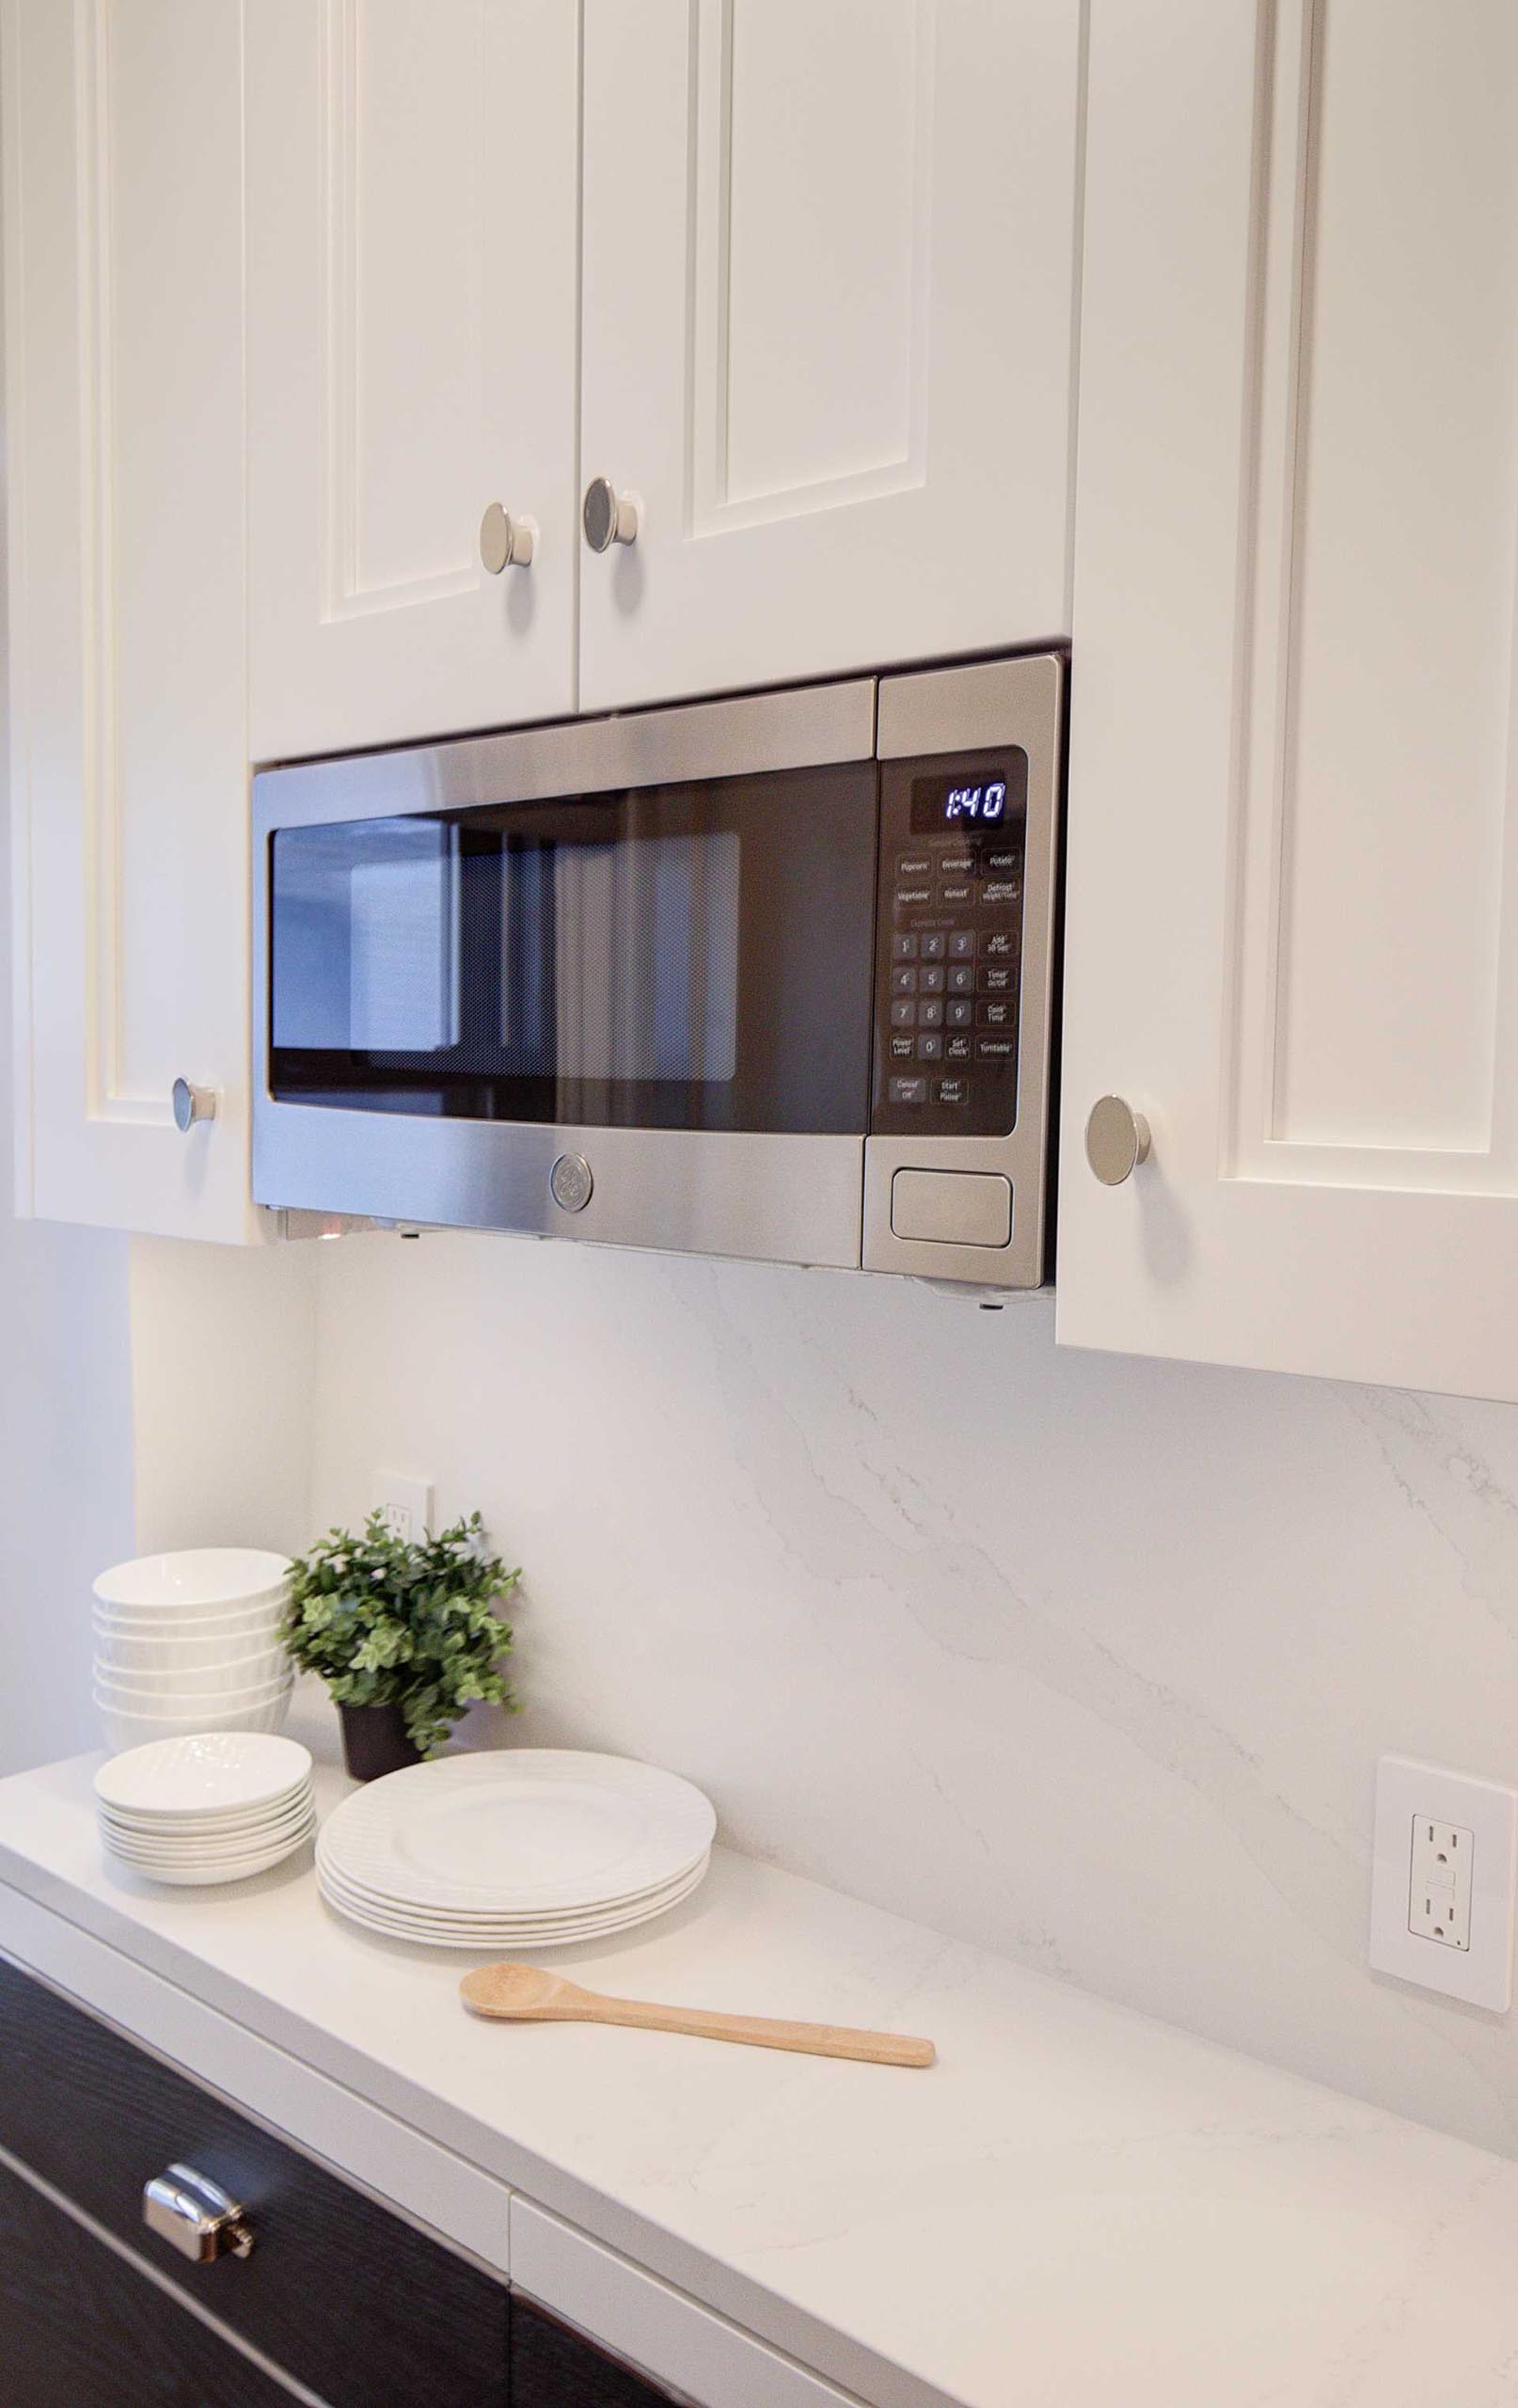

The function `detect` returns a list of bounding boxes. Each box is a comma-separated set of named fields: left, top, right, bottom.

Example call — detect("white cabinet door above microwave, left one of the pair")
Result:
left=245, top=0, right=578, bottom=761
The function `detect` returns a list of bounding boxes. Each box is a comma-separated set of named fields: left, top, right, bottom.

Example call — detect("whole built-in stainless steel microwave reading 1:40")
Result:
left=253, top=653, right=1065, bottom=1289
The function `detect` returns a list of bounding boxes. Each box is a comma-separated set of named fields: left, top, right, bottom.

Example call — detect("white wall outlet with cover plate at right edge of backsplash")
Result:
left=1371, top=1755, right=1518, bottom=2013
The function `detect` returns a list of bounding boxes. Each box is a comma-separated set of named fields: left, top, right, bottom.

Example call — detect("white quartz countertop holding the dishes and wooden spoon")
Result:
left=0, top=1695, right=1518, bottom=2408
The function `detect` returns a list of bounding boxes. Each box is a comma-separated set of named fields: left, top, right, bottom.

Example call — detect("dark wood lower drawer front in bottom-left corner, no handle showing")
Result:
left=0, top=2164, right=292, bottom=2408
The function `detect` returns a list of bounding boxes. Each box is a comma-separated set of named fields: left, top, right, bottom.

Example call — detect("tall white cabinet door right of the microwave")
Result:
left=1058, top=0, right=1518, bottom=1397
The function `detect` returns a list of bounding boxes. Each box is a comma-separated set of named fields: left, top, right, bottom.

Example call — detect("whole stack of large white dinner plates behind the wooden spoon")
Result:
left=316, top=1749, right=716, bottom=1956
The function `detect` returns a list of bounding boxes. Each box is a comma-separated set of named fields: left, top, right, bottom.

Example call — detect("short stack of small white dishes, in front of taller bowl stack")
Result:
left=94, top=1732, right=316, bottom=1883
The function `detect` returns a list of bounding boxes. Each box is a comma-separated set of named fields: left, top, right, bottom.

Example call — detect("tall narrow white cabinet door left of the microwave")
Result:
left=3, top=0, right=250, bottom=1238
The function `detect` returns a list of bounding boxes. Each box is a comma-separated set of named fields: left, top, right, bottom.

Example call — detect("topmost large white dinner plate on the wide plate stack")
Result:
left=323, top=1749, right=716, bottom=1919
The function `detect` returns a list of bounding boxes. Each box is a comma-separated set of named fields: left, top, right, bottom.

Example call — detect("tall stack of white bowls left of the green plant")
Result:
left=94, top=1546, right=294, bottom=1749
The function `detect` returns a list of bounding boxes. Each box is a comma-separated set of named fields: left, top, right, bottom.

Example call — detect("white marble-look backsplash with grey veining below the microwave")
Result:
left=313, top=1238, right=1518, bottom=2150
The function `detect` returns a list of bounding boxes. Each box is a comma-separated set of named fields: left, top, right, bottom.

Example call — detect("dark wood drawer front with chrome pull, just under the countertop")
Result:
left=0, top=1960, right=509, bottom=2408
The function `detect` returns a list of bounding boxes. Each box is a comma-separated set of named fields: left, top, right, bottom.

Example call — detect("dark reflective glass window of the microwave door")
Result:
left=270, top=764, right=878, bottom=1132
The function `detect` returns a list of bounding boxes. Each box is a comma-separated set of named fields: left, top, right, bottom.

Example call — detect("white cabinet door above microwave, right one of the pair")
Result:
left=580, top=0, right=1082, bottom=708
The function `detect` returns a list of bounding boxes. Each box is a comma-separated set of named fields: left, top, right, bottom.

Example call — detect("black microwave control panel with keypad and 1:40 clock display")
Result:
left=870, top=747, right=1029, bottom=1136
